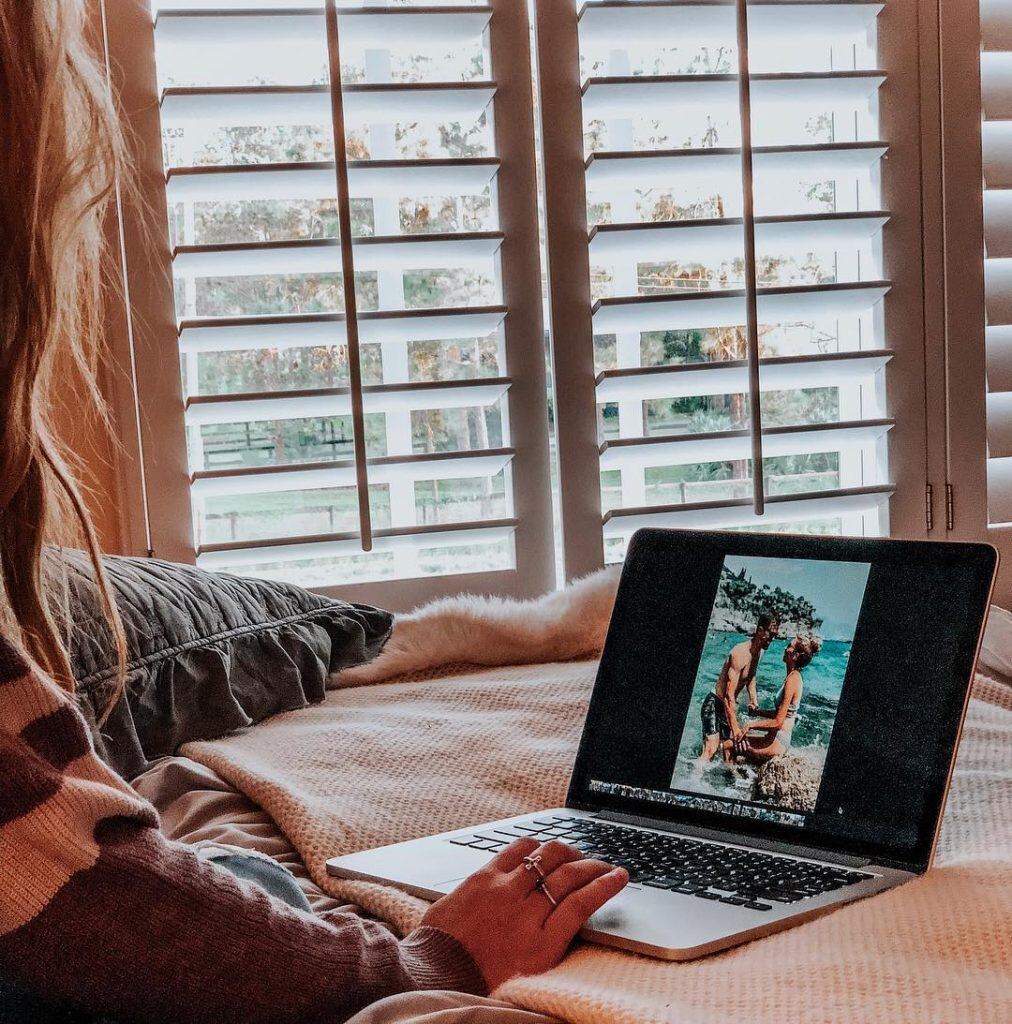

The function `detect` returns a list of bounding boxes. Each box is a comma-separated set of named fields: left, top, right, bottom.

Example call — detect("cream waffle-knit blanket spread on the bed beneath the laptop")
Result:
left=182, top=662, right=1012, bottom=1024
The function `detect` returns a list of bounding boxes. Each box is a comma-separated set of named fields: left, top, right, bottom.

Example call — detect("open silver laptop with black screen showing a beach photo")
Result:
left=328, top=529, right=998, bottom=959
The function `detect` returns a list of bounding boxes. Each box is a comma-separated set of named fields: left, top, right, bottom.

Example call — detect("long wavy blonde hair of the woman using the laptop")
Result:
left=0, top=0, right=125, bottom=704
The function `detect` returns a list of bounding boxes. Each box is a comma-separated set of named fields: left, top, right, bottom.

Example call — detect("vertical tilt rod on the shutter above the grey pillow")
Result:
left=326, top=0, right=373, bottom=551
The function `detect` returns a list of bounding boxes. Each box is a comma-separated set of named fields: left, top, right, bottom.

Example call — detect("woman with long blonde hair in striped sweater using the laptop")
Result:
left=0, top=0, right=628, bottom=1024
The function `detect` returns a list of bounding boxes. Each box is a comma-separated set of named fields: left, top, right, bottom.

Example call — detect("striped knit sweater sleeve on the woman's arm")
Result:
left=0, top=637, right=484, bottom=1024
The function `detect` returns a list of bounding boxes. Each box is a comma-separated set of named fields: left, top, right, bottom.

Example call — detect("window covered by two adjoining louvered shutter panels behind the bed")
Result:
left=106, top=0, right=950, bottom=603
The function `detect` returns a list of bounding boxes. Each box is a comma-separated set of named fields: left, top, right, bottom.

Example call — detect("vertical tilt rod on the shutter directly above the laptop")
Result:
left=735, top=0, right=766, bottom=515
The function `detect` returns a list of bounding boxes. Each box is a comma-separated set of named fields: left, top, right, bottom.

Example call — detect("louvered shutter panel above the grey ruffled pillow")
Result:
left=122, top=0, right=554, bottom=602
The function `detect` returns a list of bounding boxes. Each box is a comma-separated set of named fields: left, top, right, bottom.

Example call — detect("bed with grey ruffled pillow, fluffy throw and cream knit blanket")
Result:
left=72, top=559, right=1012, bottom=1024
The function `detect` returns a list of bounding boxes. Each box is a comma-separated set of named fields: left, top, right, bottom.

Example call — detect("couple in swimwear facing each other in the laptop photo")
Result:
left=700, top=612, right=821, bottom=765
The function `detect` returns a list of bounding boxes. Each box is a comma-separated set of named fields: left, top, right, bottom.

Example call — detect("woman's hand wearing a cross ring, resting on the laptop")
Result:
left=422, top=839, right=629, bottom=991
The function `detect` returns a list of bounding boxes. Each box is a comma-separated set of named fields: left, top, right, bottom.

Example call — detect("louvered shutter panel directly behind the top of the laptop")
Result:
left=538, top=0, right=924, bottom=571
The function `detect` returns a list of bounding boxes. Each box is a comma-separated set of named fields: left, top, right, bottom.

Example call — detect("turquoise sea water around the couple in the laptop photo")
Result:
left=672, top=631, right=850, bottom=799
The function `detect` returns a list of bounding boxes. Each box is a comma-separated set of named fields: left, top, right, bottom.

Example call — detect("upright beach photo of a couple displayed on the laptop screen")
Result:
left=671, top=555, right=871, bottom=819
